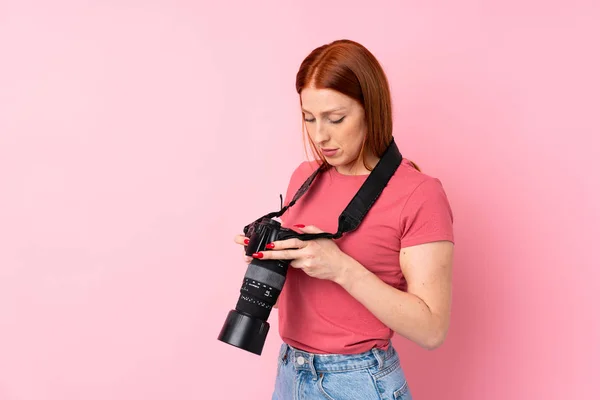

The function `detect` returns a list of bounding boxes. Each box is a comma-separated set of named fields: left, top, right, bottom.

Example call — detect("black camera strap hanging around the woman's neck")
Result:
left=248, top=137, right=402, bottom=240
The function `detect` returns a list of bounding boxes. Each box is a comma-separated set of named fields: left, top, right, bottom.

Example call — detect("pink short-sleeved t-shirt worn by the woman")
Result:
left=278, top=159, right=454, bottom=354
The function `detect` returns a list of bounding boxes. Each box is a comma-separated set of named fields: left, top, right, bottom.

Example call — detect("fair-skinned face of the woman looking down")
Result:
left=300, top=87, right=367, bottom=175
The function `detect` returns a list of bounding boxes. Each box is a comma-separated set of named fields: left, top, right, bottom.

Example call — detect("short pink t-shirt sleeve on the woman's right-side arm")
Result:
left=400, top=178, right=454, bottom=247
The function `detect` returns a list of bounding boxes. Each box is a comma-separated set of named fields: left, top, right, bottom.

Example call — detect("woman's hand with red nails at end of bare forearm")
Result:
left=253, top=225, right=350, bottom=282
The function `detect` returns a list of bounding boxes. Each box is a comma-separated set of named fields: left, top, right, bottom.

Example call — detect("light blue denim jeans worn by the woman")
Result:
left=271, top=343, right=412, bottom=400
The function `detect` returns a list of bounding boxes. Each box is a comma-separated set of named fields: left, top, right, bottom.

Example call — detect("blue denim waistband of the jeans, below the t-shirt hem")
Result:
left=279, top=343, right=398, bottom=374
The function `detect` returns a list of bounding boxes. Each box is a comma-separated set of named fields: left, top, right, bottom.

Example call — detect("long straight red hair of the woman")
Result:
left=296, top=40, right=412, bottom=170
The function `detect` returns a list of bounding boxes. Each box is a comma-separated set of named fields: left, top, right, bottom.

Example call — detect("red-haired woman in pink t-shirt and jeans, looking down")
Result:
left=235, top=40, right=454, bottom=400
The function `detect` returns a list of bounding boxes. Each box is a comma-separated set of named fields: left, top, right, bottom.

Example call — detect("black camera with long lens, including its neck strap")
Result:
left=218, top=137, right=402, bottom=355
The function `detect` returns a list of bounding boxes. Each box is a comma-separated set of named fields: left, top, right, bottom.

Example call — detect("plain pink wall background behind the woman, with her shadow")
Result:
left=0, top=0, right=600, bottom=400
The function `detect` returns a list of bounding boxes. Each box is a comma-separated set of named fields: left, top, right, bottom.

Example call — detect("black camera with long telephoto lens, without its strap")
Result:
left=218, top=217, right=300, bottom=355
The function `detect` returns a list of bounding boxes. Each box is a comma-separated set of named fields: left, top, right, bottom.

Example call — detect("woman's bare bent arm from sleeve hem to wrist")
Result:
left=336, top=241, right=454, bottom=349
